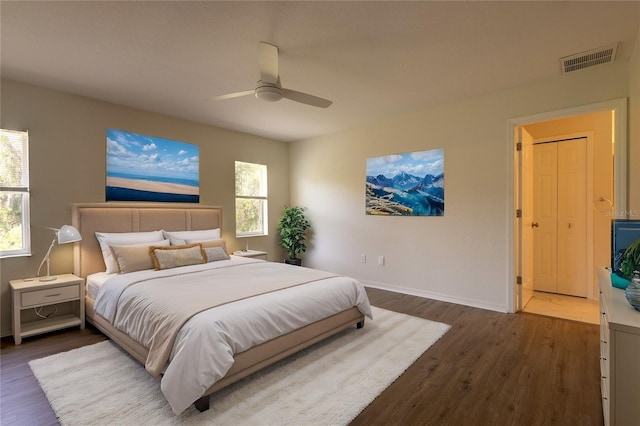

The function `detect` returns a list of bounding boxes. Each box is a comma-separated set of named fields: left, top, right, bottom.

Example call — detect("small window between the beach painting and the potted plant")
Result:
left=236, top=161, right=269, bottom=237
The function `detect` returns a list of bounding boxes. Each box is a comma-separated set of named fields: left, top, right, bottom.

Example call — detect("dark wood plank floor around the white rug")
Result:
left=0, top=289, right=603, bottom=426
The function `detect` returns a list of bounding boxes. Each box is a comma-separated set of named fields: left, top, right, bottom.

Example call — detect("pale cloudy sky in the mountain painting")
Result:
left=367, top=149, right=444, bottom=178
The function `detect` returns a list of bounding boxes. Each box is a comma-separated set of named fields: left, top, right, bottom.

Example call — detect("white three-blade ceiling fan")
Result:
left=211, top=41, right=333, bottom=108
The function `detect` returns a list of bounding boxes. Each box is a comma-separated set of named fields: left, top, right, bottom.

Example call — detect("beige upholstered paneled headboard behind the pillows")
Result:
left=71, top=202, right=222, bottom=278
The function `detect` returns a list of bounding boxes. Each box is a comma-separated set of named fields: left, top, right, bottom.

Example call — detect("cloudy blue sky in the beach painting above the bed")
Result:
left=107, top=129, right=200, bottom=181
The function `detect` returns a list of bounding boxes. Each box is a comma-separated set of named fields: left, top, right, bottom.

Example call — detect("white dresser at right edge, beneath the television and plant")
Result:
left=598, top=268, right=640, bottom=426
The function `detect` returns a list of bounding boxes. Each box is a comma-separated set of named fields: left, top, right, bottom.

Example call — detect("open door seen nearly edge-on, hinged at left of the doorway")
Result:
left=516, top=126, right=533, bottom=311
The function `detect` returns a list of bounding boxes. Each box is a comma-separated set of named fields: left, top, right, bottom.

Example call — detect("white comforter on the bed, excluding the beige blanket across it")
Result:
left=95, top=257, right=371, bottom=414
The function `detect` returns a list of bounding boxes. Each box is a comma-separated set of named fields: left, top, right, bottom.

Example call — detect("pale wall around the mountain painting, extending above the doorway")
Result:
left=290, top=63, right=638, bottom=311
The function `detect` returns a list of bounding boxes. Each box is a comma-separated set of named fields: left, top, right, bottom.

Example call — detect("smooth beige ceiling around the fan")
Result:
left=0, top=0, right=640, bottom=141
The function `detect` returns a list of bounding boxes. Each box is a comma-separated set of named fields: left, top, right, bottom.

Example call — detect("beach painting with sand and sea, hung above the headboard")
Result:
left=106, top=129, right=200, bottom=203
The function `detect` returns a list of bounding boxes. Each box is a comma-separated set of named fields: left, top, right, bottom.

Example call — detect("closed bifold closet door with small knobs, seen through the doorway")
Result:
left=533, top=139, right=587, bottom=297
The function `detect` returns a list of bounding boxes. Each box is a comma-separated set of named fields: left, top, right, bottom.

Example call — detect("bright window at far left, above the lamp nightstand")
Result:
left=0, top=129, right=31, bottom=257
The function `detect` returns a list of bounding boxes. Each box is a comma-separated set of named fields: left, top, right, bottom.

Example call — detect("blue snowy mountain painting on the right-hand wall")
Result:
left=365, top=149, right=444, bottom=216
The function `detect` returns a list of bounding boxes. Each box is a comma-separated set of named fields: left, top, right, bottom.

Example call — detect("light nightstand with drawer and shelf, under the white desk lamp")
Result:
left=9, top=274, right=84, bottom=345
